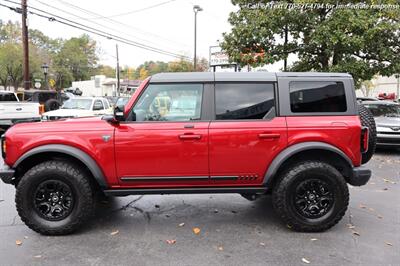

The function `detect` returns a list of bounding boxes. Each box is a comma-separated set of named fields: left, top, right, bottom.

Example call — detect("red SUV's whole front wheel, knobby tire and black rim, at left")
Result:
left=15, top=161, right=95, bottom=235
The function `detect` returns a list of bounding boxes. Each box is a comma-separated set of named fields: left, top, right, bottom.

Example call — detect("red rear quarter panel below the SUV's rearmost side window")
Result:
left=286, top=116, right=361, bottom=166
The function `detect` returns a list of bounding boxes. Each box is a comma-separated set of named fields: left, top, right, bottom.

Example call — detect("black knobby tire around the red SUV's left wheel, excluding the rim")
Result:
left=15, top=161, right=96, bottom=235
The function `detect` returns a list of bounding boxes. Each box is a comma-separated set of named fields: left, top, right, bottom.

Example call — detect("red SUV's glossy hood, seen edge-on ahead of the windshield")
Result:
left=6, top=116, right=113, bottom=135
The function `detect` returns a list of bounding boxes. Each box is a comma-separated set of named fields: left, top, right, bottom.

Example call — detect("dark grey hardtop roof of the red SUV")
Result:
left=150, top=72, right=351, bottom=83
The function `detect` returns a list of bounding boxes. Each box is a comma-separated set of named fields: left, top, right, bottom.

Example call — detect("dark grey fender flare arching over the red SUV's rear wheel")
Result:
left=263, top=141, right=353, bottom=186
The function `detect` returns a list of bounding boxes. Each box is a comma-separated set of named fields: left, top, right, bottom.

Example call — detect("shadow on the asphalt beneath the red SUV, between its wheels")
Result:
left=80, top=194, right=288, bottom=233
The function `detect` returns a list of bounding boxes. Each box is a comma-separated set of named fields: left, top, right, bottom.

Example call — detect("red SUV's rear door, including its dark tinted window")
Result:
left=209, top=82, right=287, bottom=186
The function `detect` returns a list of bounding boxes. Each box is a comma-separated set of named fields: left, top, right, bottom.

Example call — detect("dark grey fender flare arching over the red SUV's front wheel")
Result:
left=12, top=144, right=108, bottom=189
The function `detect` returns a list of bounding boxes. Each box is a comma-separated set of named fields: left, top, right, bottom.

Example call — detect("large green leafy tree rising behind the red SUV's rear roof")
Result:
left=221, top=0, right=400, bottom=86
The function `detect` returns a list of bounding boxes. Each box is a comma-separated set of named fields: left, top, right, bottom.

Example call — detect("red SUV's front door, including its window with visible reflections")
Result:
left=115, top=83, right=209, bottom=188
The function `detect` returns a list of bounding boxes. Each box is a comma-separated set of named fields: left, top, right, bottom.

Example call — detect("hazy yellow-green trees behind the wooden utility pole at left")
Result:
left=0, top=20, right=98, bottom=88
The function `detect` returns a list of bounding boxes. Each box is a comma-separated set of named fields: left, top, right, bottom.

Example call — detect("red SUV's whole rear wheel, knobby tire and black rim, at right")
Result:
left=272, top=161, right=349, bottom=232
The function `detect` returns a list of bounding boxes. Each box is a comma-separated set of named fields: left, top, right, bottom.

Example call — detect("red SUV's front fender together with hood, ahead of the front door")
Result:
left=5, top=117, right=118, bottom=185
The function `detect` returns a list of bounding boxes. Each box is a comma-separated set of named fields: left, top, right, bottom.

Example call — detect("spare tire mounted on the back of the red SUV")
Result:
left=358, top=104, right=376, bottom=164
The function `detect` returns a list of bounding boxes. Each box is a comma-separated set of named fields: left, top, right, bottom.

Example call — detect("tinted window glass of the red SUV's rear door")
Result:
left=215, top=83, right=275, bottom=120
